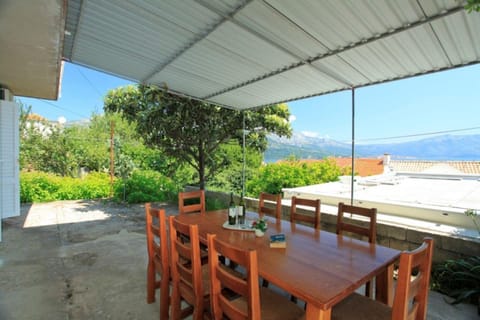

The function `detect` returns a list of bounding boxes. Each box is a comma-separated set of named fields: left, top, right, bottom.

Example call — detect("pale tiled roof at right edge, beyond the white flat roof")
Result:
left=389, top=160, right=480, bottom=175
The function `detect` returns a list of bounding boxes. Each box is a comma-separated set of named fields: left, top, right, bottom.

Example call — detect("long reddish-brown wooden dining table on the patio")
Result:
left=177, top=210, right=400, bottom=320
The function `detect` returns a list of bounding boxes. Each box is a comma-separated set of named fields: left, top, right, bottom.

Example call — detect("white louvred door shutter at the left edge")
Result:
left=0, top=100, right=20, bottom=241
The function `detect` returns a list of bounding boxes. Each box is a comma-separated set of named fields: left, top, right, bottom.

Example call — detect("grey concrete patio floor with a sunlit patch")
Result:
left=0, top=201, right=480, bottom=320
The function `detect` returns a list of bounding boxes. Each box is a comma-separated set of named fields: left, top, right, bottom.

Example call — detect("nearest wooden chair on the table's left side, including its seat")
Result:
left=207, top=234, right=304, bottom=320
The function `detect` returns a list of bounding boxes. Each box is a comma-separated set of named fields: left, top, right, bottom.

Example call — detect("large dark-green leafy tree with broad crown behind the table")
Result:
left=104, top=85, right=291, bottom=189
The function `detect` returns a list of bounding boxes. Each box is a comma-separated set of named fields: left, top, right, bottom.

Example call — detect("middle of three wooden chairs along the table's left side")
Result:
left=169, top=216, right=210, bottom=320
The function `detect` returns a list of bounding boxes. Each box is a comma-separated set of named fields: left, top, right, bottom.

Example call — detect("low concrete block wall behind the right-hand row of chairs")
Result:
left=207, top=191, right=480, bottom=263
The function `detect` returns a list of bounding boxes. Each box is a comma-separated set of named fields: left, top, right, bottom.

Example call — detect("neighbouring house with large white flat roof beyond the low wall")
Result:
left=283, top=154, right=480, bottom=234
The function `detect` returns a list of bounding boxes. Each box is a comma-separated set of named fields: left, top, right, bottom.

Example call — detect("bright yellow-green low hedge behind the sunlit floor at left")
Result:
left=20, top=172, right=110, bottom=203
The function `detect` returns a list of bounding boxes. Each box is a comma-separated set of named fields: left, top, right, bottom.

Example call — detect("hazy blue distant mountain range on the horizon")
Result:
left=265, top=133, right=480, bottom=162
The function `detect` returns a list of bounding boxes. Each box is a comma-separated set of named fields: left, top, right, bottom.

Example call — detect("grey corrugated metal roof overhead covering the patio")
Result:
left=64, top=0, right=480, bottom=109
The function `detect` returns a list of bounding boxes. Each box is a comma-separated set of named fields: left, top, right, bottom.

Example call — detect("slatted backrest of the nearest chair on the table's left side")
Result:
left=207, top=234, right=261, bottom=320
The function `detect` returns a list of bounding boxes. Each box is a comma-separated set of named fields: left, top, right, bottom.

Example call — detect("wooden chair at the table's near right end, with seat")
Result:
left=332, top=238, right=433, bottom=320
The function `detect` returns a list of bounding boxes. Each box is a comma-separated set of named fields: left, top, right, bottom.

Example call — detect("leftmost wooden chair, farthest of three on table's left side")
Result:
left=145, top=203, right=170, bottom=319
